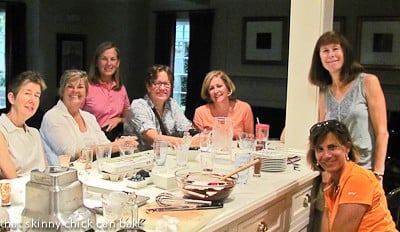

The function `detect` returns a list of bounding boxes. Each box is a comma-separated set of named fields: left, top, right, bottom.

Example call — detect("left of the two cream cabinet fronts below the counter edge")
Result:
left=237, top=200, right=288, bottom=232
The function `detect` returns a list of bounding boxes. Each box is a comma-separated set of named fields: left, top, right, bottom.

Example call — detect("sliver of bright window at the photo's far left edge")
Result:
left=0, top=10, right=6, bottom=109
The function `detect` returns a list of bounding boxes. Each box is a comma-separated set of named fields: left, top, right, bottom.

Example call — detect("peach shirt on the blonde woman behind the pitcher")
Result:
left=193, top=100, right=254, bottom=139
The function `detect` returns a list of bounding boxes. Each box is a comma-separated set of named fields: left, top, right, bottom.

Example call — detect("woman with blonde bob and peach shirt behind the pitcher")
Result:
left=193, top=70, right=254, bottom=139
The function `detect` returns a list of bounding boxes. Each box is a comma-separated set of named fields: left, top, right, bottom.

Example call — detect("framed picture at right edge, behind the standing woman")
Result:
left=357, top=17, right=400, bottom=69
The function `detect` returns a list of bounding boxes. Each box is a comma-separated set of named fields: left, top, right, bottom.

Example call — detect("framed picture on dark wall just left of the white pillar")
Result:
left=242, top=17, right=288, bottom=64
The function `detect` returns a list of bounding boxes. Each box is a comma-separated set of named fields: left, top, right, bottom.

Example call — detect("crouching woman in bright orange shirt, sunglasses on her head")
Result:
left=307, top=120, right=397, bottom=231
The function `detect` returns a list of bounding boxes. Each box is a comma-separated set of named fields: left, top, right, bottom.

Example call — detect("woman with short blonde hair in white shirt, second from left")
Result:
left=40, top=69, right=135, bottom=165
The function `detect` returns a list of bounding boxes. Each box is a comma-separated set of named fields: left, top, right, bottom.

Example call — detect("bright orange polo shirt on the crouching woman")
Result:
left=324, top=161, right=397, bottom=231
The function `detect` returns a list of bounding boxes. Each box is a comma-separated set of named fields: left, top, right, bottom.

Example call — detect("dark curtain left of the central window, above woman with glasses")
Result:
left=154, top=12, right=176, bottom=68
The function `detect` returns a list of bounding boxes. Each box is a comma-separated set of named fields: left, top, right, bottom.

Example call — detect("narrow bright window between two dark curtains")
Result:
left=173, top=19, right=190, bottom=111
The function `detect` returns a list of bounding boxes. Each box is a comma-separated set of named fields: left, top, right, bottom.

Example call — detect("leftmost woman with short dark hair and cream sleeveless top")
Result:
left=0, top=71, right=47, bottom=179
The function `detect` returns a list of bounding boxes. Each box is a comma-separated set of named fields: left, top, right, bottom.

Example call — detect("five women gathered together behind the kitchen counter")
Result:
left=0, top=42, right=254, bottom=178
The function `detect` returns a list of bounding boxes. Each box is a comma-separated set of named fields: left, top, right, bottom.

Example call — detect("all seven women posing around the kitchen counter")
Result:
left=0, top=32, right=393, bottom=231
